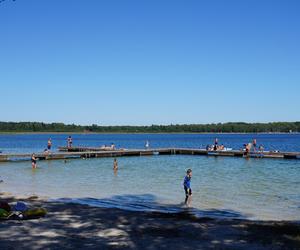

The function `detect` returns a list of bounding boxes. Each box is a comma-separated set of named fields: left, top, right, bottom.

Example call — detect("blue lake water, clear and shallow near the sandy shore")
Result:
left=0, top=134, right=300, bottom=221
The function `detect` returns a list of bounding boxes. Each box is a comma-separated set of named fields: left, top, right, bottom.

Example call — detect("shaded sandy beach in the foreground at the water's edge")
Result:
left=0, top=193, right=300, bottom=249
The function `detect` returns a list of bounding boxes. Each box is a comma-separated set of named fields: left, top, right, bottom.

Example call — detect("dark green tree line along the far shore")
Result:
left=0, top=122, right=300, bottom=133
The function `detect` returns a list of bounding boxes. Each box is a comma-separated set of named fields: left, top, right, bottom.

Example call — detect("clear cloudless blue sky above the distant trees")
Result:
left=0, top=0, right=300, bottom=125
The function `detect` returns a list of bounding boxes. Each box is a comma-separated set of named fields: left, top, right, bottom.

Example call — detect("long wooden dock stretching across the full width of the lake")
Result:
left=0, top=147, right=300, bottom=162
